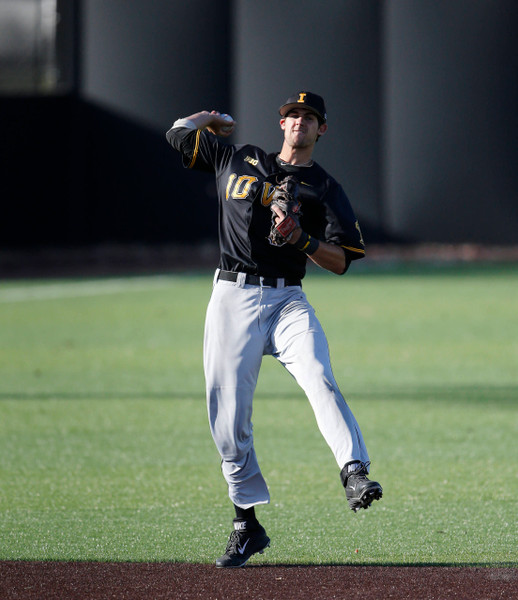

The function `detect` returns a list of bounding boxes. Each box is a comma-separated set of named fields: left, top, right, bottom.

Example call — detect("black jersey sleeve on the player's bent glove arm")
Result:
left=324, top=181, right=365, bottom=260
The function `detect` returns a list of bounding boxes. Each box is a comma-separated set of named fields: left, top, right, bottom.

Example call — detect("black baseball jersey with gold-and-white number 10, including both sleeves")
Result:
left=166, top=127, right=365, bottom=279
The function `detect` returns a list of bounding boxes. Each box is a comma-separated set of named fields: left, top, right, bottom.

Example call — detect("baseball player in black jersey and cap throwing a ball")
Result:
left=166, top=91, right=382, bottom=567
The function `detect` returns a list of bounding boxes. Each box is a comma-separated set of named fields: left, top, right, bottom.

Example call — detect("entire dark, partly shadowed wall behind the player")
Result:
left=0, top=0, right=518, bottom=248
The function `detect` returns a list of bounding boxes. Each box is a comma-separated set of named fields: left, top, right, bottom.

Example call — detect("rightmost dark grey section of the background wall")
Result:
left=383, top=0, right=518, bottom=244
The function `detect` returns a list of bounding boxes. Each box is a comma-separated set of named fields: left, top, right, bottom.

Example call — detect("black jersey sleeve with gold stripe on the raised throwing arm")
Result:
left=166, top=127, right=231, bottom=173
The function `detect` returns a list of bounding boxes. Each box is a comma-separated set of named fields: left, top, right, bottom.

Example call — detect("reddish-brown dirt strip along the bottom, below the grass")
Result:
left=0, top=561, right=518, bottom=600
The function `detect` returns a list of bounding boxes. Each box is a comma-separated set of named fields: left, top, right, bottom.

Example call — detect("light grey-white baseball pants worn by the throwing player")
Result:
left=204, top=270, right=369, bottom=509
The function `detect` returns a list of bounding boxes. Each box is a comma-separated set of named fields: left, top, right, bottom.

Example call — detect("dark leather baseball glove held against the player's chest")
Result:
left=268, top=175, right=302, bottom=246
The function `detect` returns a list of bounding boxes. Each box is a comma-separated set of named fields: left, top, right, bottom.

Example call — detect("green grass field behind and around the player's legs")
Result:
left=0, top=265, right=518, bottom=566
